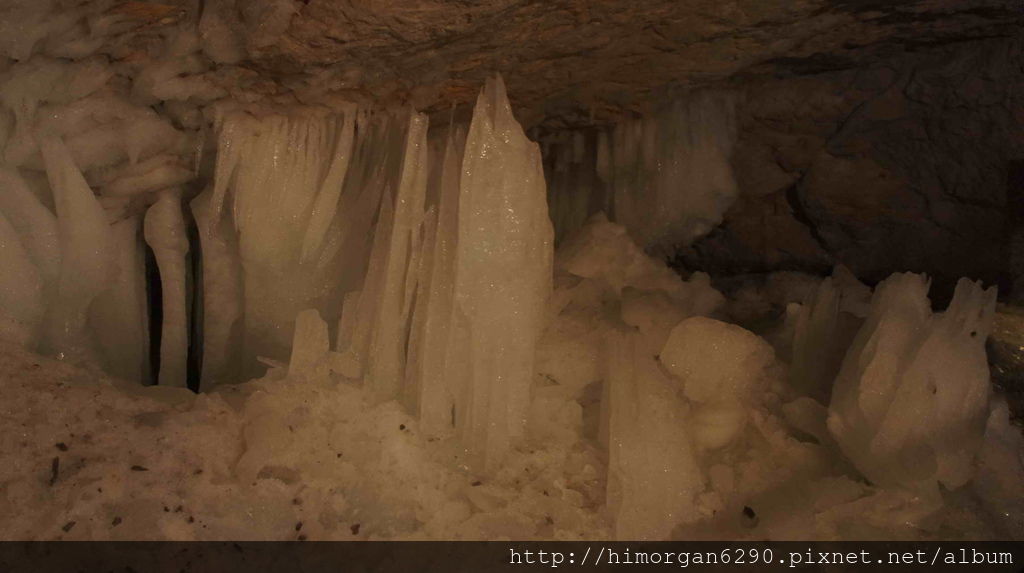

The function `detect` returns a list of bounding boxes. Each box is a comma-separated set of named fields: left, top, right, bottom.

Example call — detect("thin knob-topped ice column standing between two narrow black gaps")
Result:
left=144, top=189, right=188, bottom=387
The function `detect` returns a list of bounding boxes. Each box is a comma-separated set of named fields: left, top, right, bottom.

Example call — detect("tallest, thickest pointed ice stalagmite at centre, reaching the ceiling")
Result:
left=453, top=78, right=553, bottom=469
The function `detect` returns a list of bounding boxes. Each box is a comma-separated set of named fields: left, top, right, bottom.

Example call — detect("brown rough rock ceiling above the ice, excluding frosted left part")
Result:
left=235, top=0, right=1022, bottom=123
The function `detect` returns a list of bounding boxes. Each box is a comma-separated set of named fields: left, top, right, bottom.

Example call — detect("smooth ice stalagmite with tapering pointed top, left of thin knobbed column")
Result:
left=41, top=137, right=115, bottom=358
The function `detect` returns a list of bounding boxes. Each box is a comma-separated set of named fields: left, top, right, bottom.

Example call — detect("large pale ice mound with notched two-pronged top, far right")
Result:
left=828, top=273, right=996, bottom=488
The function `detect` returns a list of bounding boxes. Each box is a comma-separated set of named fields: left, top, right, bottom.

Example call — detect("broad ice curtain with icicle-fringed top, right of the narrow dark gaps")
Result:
left=203, top=108, right=355, bottom=374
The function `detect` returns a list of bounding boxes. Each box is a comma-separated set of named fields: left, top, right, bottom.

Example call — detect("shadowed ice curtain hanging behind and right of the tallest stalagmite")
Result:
left=547, top=91, right=738, bottom=249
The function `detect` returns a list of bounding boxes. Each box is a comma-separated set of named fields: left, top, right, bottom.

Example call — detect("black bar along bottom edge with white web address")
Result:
left=0, top=541, right=1024, bottom=573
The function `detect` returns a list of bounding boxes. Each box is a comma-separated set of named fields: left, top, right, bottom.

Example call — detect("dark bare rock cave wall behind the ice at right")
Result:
left=681, top=38, right=1024, bottom=298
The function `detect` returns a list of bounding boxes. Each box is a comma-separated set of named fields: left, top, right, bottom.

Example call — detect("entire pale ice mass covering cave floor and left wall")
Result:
left=0, top=7, right=1024, bottom=539
